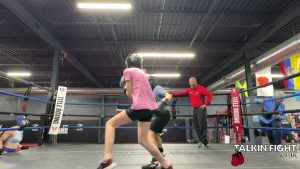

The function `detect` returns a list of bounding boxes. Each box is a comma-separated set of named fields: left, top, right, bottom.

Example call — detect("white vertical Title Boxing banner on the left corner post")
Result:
left=48, top=86, right=67, bottom=135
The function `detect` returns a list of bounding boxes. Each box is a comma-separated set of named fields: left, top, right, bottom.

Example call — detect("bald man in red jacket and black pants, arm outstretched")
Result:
left=172, top=77, right=213, bottom=148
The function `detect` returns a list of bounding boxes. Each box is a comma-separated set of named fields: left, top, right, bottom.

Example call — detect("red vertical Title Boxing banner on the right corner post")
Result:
left=230, top=88, right=243, bottom=134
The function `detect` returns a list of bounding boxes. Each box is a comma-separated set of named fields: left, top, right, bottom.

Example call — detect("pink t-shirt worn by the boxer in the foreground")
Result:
left=123, top=68, right=158, bottom=110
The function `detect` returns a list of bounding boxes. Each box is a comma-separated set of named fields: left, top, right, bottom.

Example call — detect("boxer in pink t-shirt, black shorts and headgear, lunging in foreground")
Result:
left=98, top=55, right=173, bottom=169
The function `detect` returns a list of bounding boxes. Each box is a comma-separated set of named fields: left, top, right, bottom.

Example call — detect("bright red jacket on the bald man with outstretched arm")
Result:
left=172, top=85, right=213, bottom=109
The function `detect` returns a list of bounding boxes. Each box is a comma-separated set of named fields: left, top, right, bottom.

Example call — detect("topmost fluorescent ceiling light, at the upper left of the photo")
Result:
left=77, top=3, right=132, bottom=10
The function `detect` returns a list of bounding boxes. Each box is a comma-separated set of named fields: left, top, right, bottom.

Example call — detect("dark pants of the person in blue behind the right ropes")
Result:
left=260, top=120, right=282, bottom=145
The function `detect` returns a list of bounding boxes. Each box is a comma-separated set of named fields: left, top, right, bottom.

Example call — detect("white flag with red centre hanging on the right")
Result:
left=255, top=68, right=274, bottom=97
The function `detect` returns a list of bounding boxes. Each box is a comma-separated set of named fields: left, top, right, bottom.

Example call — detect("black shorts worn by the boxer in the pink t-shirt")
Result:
left=126, top=109, right=153, bottom=122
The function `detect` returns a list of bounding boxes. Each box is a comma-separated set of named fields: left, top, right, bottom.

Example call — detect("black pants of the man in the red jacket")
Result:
left=193, top=108, right=208, bottom=145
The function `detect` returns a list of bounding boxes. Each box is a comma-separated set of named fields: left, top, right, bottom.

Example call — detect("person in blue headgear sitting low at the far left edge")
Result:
left=0, top=115, right=30, bottom=155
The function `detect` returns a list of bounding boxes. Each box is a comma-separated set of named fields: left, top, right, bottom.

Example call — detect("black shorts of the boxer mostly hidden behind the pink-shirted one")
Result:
left=150, top=111, right=171, bottom=133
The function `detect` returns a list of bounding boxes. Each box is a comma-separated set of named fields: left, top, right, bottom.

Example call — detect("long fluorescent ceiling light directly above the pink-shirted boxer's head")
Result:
left=134, top=53, right=195, bottom=58
